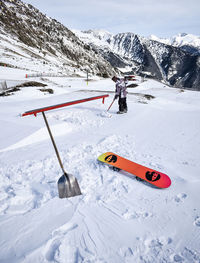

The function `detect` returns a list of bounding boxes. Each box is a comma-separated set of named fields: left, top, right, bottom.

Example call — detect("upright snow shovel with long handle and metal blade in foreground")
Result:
left=42, top=112, right=81, bottom=198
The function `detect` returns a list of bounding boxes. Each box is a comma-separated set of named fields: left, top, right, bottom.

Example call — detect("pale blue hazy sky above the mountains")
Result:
left=22, top=0, right=200, bottom=37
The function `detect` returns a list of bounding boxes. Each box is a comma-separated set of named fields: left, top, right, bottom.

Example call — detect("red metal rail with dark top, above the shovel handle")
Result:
left=22, top=94, right=109, bottom=117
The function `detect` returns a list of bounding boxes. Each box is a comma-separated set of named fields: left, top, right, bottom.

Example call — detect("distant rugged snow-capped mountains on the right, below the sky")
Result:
left=75, top=31, right=200, bottom=90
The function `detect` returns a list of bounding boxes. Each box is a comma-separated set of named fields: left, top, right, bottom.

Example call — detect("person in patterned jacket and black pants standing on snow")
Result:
left=112, top=76, right=128, bottom=114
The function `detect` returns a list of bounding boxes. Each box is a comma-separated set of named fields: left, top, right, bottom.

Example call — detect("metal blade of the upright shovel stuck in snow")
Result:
left=58, top=174, right=81, bottom=198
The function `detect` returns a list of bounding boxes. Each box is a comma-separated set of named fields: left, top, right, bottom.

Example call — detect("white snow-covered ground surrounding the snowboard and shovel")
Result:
left=0, top=67, right=200, bottom=263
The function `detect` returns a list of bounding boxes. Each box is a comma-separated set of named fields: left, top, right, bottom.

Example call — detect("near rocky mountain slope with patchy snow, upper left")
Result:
left=0, top=0, right=114, bottom=77
